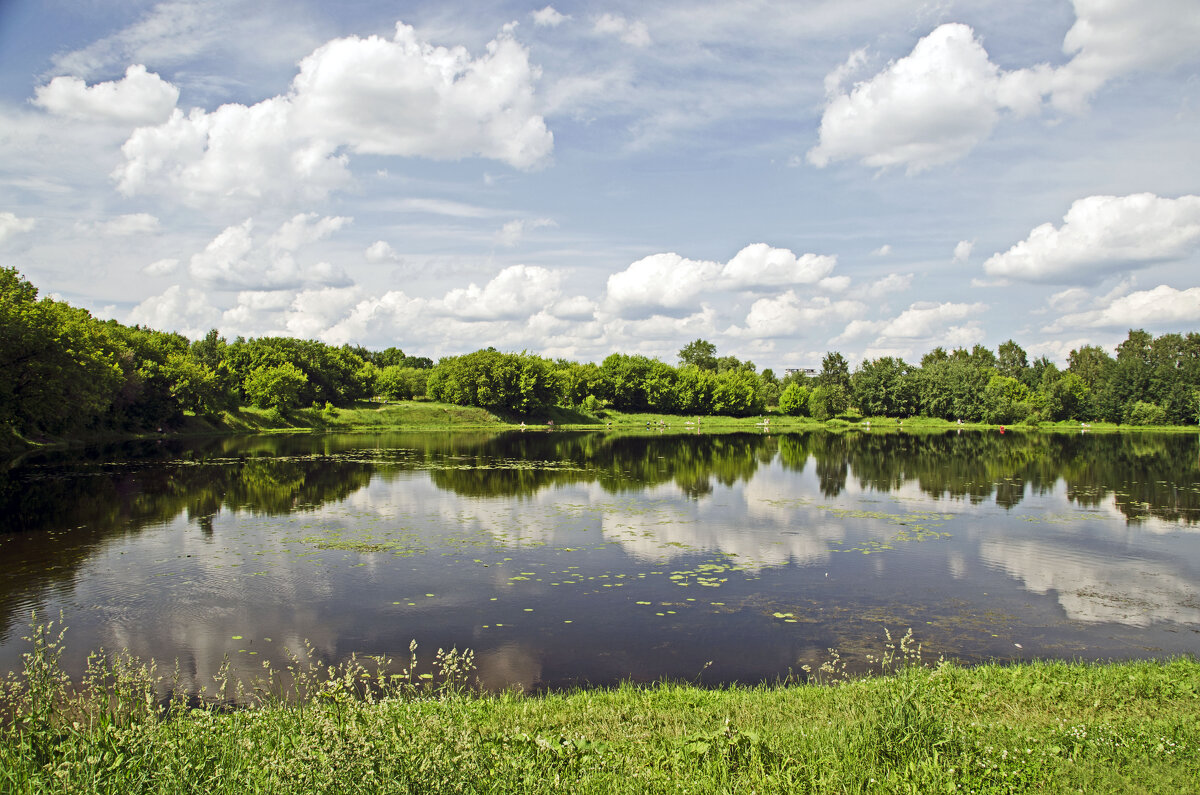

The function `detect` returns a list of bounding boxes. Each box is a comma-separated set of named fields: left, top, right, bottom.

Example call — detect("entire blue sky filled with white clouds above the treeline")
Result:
left=0, top=0, right=1200, bottom=372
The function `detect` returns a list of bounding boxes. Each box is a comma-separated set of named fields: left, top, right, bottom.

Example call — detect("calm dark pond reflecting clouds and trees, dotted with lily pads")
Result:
left=0, top=428, right=1200, bottom=689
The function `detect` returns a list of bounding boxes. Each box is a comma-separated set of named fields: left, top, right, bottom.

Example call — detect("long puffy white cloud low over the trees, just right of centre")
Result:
left=607, top=243, right=848, bottom=312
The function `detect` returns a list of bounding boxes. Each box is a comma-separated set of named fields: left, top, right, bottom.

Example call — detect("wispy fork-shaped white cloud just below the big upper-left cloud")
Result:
left=188, top=214, right=350, bottom=289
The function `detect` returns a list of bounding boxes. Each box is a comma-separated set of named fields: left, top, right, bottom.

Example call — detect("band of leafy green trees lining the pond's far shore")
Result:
left=0, top=268, right=1200, bottom=438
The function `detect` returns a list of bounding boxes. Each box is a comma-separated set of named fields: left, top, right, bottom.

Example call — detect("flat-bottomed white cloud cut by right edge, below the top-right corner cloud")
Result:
left=984, top=193, right=1200, bottom=282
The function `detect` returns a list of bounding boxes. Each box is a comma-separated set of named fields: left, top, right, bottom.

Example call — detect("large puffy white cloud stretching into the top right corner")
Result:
left=808, top=0, right=1200, bottom=173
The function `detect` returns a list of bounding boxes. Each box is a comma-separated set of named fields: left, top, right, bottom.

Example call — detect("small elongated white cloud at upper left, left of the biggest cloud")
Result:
left=32, top=64, right=179, bottom=125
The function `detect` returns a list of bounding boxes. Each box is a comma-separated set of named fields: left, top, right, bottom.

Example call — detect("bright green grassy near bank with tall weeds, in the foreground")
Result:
left=0, top=630, right=1200, bottom=794
